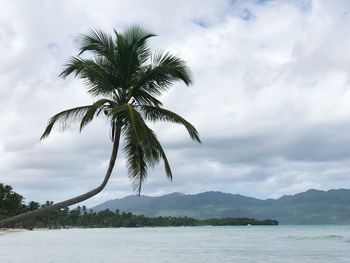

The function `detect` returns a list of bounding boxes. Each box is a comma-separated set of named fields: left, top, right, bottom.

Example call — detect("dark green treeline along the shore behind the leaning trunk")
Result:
left=0, top=183, right=278, bottom=229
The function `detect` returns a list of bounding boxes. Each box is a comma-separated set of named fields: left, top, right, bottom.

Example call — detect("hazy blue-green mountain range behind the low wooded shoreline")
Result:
left=92, top=189, right=350, bottom=224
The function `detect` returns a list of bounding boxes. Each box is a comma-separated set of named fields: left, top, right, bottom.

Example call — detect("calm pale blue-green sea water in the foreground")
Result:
left=0, top=226, right=350, bottom=263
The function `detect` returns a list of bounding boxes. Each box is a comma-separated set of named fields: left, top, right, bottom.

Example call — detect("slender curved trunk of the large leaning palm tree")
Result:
left=0, top=129, right=120, bottom=227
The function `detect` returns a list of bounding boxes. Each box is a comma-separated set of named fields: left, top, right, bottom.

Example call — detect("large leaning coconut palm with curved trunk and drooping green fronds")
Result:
left=0, top=26, right=200, bottom=229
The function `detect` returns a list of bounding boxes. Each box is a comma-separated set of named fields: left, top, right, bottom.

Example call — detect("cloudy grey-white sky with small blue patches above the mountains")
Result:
left=0, top=0, right=350, bottom=206
